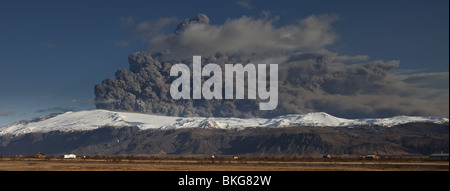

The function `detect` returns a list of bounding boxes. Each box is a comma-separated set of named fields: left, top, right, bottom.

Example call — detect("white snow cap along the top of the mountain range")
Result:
left=0, top=109, right=449, bottom=136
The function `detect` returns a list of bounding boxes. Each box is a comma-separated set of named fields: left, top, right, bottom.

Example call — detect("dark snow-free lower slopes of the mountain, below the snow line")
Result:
left=0, top=123, right=449, bottom=157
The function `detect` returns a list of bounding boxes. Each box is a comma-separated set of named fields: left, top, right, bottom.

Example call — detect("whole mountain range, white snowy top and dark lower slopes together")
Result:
left=0, top=110, right=449, bottom=157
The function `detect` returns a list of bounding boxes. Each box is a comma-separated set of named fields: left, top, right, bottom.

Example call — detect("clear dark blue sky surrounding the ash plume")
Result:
left=0, top=0, right=449, bottom=126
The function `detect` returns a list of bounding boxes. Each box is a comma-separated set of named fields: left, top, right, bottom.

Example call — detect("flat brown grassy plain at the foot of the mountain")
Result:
left=0, top=157, right=449, bottom=171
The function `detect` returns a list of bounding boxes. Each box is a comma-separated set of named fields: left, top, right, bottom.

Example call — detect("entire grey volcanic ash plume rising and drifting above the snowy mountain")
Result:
left=95, top=14, right=449, bottom=118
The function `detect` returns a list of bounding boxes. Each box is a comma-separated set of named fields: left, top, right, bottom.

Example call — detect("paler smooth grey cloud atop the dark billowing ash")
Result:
left=148, top=14, right=338, bottom=59
